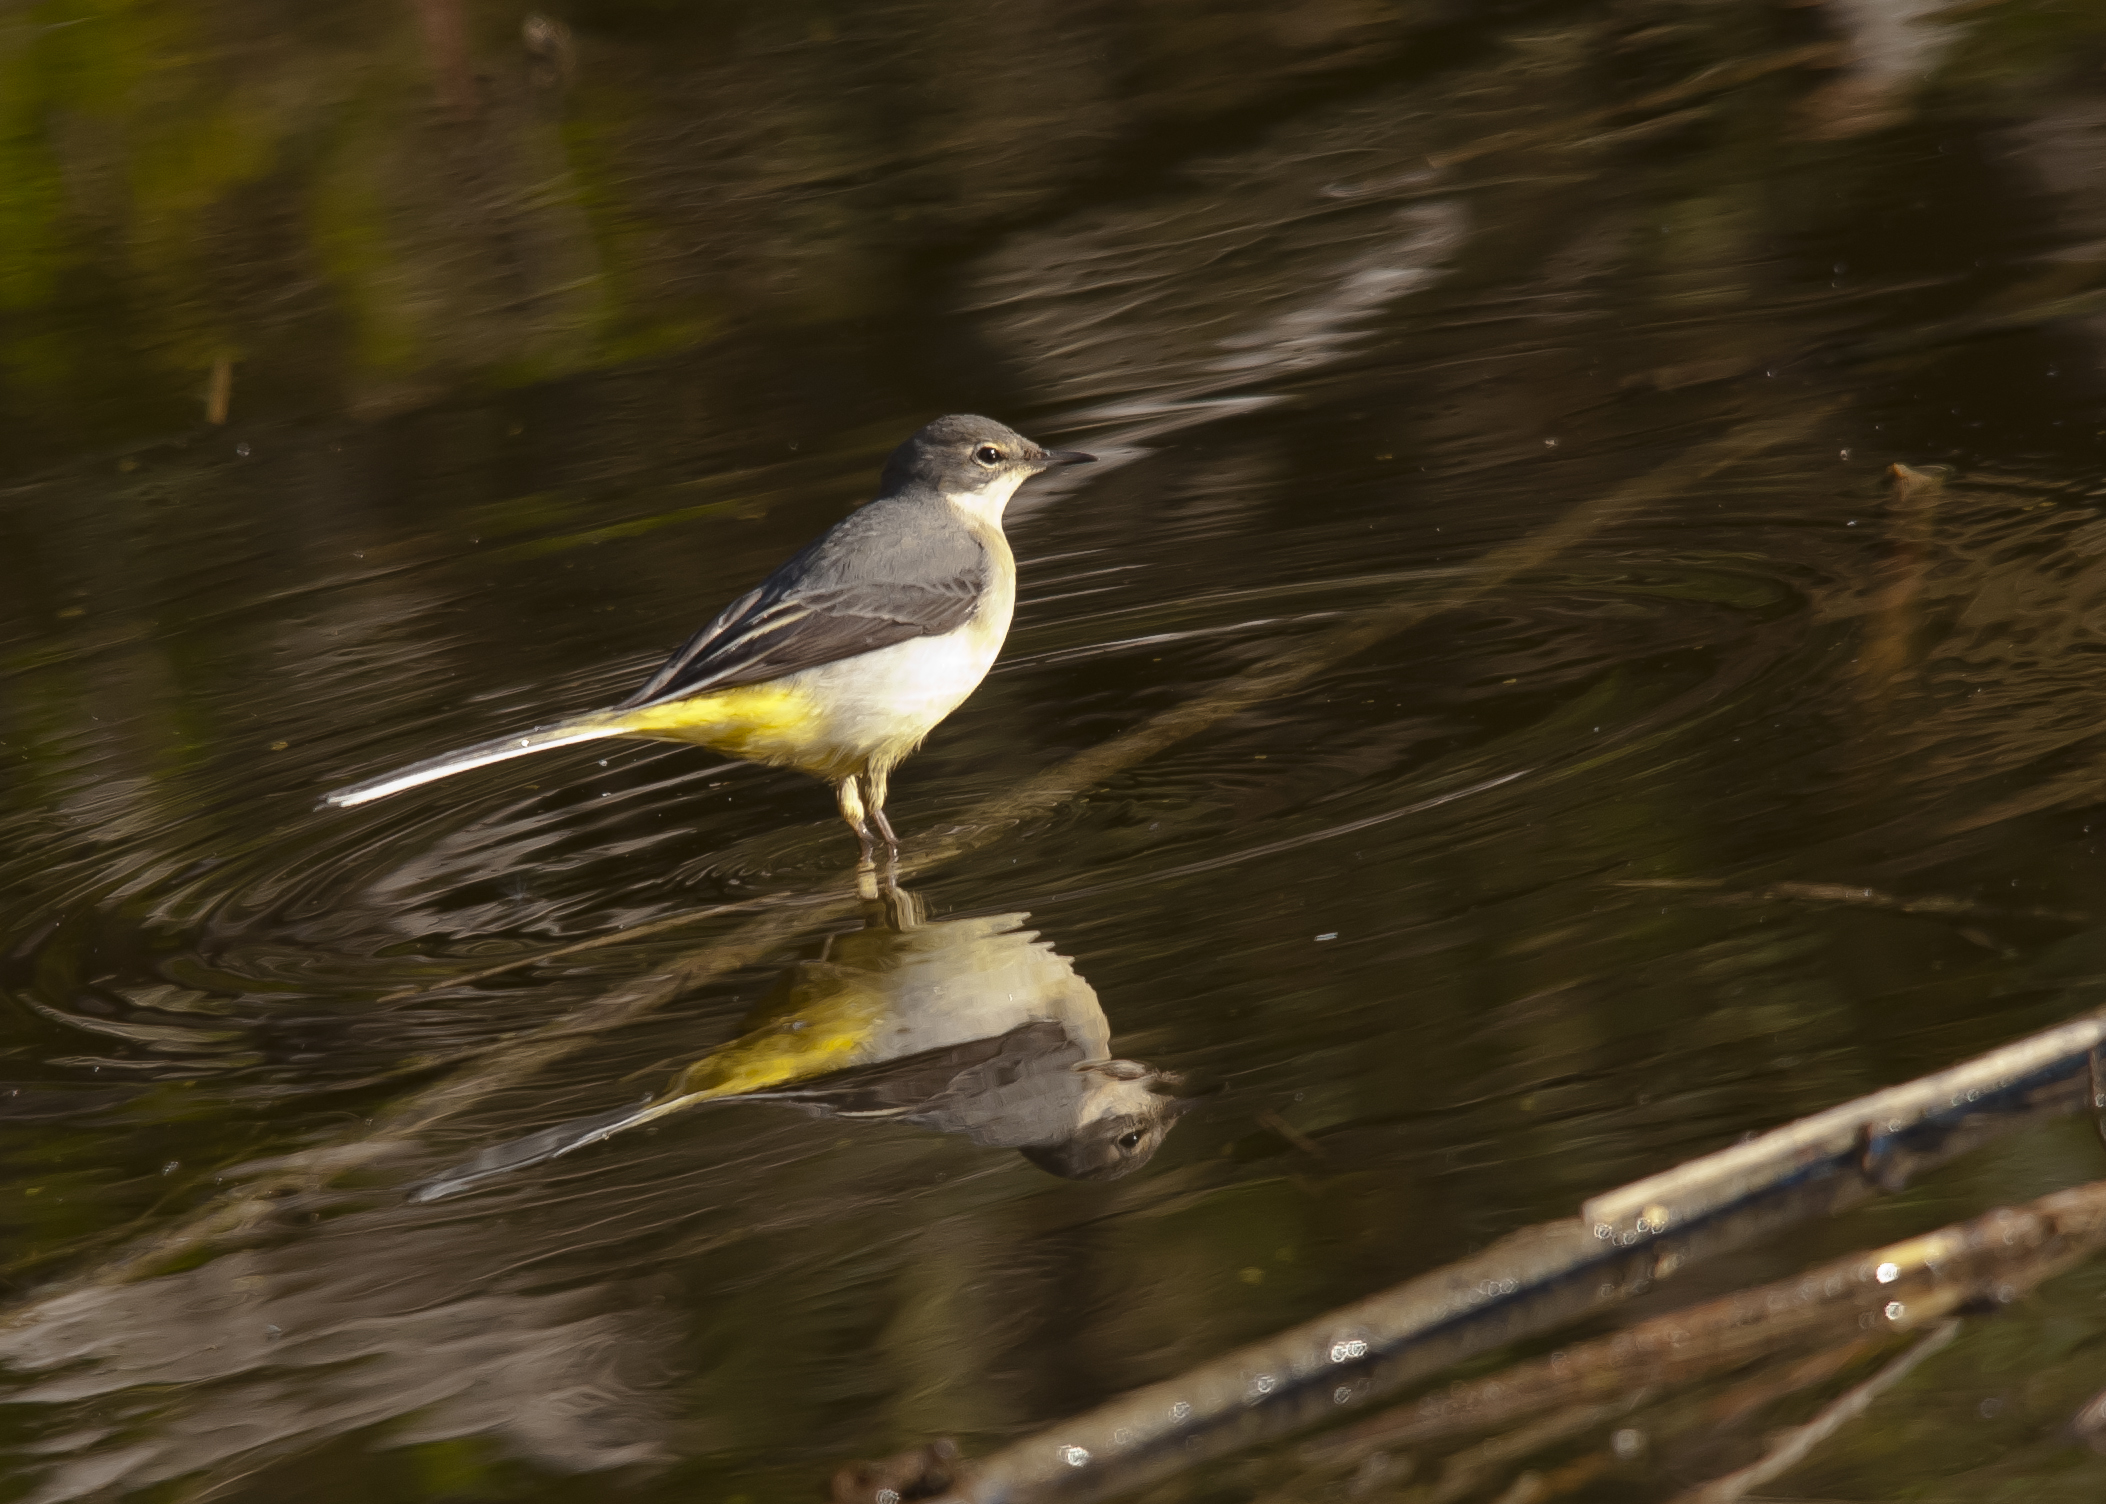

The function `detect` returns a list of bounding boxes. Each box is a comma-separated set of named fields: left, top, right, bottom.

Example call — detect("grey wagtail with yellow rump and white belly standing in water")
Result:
left=322, top=413, right=1095, bottom=868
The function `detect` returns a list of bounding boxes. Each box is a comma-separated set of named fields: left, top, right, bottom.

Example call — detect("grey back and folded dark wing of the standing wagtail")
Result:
left=617, top=503, right=988, bottom=710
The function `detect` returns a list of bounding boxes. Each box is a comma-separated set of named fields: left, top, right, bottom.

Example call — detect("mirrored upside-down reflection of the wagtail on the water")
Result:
left=411, top=889, right=1198, bottom=1201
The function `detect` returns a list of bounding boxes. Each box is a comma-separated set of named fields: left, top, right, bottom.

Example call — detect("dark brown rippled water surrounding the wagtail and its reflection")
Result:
left=0, top=0, right=2106, bottom=1500
